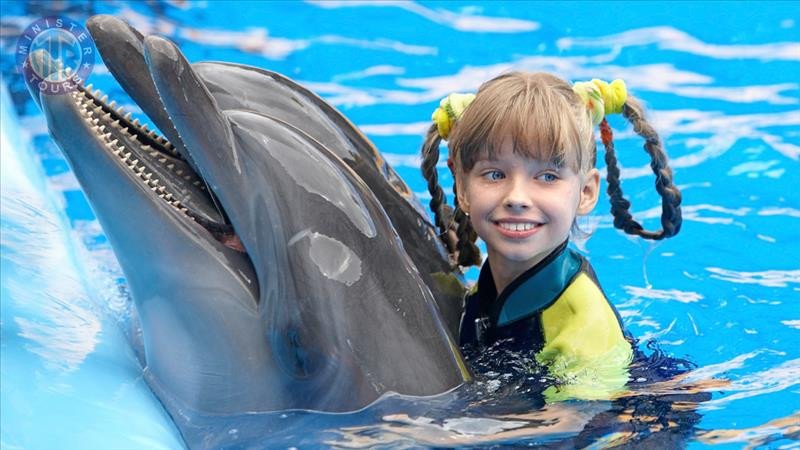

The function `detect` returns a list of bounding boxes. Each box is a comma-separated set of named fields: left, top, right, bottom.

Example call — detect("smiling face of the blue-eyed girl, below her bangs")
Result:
left=458, top=139, right=600, bottom=277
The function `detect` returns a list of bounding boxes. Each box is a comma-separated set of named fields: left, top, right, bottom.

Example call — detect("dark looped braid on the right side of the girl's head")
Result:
left=600, top=98, right=682, bottom=240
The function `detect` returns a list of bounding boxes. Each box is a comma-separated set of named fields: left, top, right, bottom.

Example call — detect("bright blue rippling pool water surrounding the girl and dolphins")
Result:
left=0, top=1, right=800, bottom=449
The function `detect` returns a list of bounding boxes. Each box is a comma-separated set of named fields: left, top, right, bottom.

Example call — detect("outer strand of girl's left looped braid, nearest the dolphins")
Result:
left=421, top=124, right=456, bottom=254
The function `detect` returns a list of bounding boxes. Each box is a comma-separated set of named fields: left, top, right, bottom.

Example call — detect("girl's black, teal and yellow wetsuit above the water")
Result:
left=459, top=242, right=632, bottom=398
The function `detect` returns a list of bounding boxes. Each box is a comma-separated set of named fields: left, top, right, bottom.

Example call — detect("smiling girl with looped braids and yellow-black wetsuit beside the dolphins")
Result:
left=422, top=72, right=681, bottom=400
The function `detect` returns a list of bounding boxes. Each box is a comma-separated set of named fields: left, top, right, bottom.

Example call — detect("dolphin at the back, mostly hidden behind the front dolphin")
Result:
left=87, top=15, right=465, bottom=335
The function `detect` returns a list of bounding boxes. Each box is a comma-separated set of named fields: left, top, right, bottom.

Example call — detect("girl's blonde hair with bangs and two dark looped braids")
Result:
left=422, top=72, right=681, bottom=266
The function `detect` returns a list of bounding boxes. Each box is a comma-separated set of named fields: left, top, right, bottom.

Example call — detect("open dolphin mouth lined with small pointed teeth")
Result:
left=69, top=78, right=246, bottom=253
